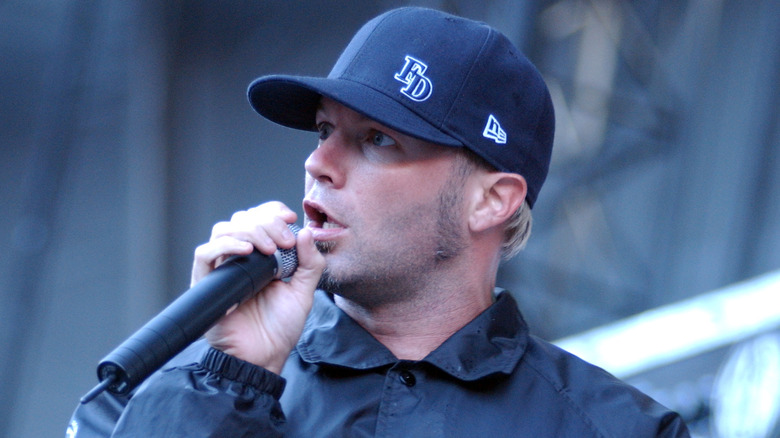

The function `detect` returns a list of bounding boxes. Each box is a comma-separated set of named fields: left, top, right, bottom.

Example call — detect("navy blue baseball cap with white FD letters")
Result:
left=248, top=7, right=555, bottom=206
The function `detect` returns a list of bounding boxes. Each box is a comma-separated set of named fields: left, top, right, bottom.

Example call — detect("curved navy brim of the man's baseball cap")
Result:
left=247, top=75, right=463, bottom=147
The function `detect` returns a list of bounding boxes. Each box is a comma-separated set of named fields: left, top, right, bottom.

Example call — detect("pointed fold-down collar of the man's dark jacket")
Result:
left=297, top=291, right=528, bottom=381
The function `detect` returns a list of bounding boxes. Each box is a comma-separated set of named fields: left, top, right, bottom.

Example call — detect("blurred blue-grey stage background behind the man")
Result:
left=0, top=0, right=780, bottom=437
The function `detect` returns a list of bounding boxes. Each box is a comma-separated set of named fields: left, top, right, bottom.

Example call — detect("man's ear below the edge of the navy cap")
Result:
left=469, top=172, right=528, bottom=232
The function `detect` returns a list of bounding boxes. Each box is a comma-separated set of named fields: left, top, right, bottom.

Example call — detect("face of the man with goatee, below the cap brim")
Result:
left=304, top=98, right=468, bottom=304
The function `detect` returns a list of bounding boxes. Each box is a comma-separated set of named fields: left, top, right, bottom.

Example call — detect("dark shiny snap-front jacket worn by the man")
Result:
left=71, top=292, right=689, bottom=438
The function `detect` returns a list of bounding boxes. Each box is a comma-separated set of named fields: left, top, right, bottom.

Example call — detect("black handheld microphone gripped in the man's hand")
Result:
left=81, top=225, right=300, bottom=404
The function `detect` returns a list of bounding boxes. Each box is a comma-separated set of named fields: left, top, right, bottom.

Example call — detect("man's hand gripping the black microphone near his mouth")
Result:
left=192, top=202, right=325, bottom=373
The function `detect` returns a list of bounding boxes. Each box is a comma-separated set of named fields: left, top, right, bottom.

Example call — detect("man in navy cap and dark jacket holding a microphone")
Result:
left=71, top=8, right=688, bottom=437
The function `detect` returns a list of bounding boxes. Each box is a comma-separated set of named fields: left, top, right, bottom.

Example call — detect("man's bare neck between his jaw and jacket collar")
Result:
left=335, top=229, right=501, bottom=361
